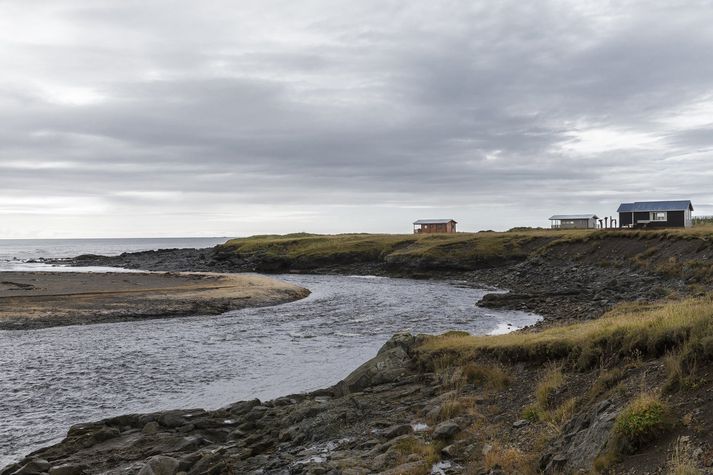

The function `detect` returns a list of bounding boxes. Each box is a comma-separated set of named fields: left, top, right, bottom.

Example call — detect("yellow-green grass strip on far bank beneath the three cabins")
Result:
left=220, top=225, right=713, bottom=272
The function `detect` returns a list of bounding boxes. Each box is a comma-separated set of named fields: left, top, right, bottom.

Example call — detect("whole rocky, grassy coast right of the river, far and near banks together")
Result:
left=9, top=228, right=713, bottom=475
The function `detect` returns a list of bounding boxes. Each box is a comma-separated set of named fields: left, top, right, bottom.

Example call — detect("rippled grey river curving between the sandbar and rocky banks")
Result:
left=0, top=275, right=540, bottom=466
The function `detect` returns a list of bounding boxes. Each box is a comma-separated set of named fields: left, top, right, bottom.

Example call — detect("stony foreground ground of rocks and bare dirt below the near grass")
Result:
left=5, top=334, right=713, bottom=475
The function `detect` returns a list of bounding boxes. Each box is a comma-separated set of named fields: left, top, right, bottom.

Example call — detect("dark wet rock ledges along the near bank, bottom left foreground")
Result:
left=0, top=335, right=436, bottom=475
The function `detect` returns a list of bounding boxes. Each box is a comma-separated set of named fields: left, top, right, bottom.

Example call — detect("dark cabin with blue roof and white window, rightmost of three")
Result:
left=617, top=200, right=693, bottom=228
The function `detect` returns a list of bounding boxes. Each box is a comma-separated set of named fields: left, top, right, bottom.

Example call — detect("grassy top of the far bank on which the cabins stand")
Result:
left=219, top=226, right=713, bottom=279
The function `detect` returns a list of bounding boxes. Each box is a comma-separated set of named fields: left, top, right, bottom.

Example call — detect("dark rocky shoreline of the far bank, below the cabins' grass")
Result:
left=42, top=240, right=690, bottom=326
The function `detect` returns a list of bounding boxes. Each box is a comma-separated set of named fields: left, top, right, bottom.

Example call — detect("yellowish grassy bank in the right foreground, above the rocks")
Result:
left=408, top=294, right=713, bottom=474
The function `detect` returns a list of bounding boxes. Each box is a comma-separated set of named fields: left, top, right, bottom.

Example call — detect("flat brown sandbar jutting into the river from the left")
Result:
left=0, top=272, right=309, bottom=330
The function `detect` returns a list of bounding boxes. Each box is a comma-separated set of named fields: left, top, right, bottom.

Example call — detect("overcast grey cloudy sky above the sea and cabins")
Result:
left=0, top=0, right=713, bottom=238
